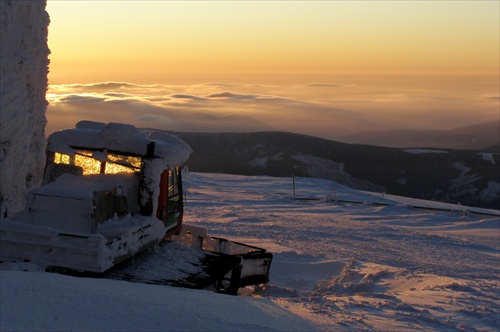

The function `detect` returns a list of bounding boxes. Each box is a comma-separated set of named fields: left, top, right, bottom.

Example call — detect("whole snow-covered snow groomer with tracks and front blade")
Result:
left=0, top=121, right=272, bottom=294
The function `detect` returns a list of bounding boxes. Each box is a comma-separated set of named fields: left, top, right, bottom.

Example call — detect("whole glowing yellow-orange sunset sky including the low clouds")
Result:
left=47, top=0, right=500, bottom=138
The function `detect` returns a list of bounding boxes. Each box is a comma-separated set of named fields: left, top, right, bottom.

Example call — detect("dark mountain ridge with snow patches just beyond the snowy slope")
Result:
left=150, top=131, right=500, bottom=209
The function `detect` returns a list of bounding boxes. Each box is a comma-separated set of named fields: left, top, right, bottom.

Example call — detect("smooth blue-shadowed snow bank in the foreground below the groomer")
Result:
left=0, top=271, right=312, bottom=331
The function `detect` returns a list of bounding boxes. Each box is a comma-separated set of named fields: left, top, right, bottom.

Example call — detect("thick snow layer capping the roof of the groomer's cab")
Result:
left=47, top=121, right=193, bottom=166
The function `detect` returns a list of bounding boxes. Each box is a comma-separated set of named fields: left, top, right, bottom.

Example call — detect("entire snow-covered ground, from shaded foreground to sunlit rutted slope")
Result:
left=0, top=173, right=500, bottom=331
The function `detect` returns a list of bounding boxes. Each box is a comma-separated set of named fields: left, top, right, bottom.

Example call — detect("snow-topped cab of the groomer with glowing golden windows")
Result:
left=41, top=121, right=192, bottom=237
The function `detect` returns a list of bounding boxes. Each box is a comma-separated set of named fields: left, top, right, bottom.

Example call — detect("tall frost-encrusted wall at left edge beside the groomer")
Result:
left=0, top=0, right=50, bottom=218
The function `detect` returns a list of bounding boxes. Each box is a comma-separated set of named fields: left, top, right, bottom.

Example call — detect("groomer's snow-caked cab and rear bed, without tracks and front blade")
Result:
left=0, top=121, right=192, bottom=273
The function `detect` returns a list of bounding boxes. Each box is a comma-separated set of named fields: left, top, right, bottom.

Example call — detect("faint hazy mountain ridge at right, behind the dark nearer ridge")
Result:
left=341, top=121, right=500, bottom=151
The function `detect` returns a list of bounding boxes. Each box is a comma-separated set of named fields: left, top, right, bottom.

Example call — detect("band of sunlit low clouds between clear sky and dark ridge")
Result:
left=47, top=76, right=498, bottom=139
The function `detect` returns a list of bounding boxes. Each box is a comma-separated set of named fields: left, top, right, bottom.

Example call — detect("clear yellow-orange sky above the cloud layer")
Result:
left=47, top=0, right=500, bottom=83
